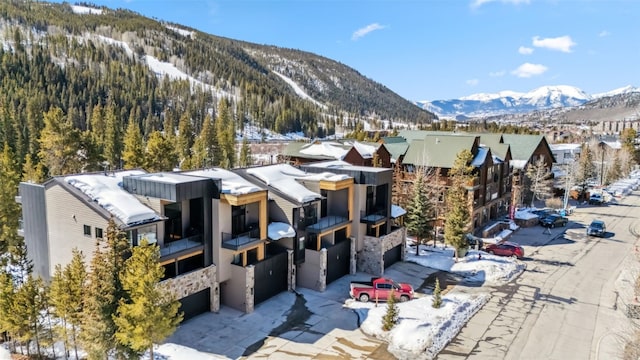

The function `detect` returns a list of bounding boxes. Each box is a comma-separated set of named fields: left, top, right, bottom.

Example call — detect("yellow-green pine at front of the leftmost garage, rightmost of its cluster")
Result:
left=114, top=239, right=182, bottom=359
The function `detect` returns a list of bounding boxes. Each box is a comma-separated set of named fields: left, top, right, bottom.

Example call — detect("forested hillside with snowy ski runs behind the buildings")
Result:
left=0, top=1, right=433, bottom=180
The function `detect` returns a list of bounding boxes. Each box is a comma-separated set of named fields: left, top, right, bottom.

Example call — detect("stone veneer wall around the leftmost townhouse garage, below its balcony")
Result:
left=160, top=265, right=220, bottom=312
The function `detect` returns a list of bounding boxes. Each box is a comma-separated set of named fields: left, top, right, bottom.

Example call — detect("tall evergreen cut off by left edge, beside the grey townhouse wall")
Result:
left=0, top=143, right=22, bottom=254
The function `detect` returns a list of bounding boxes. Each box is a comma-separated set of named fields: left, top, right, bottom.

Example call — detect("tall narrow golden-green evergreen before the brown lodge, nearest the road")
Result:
left=444, top=150, right=473, bottom=261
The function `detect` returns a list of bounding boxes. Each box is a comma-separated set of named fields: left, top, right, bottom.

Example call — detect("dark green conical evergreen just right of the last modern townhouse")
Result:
left=406, top=169, right=433, bottom=255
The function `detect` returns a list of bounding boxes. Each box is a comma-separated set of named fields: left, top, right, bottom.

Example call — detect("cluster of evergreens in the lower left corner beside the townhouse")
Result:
left=0, top=220, right=182, bottom=359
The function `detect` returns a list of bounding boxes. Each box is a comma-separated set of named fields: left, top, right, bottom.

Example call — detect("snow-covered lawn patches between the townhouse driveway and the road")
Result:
left=345, top=245, right=525, bottom=359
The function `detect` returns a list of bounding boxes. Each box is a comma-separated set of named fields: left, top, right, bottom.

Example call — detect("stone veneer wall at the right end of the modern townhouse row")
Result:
left=358, top=227, right=406, bottom=276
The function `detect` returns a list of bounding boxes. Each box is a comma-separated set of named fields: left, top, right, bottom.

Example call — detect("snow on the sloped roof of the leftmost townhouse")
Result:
left=64, top=170, right=161, bottom=225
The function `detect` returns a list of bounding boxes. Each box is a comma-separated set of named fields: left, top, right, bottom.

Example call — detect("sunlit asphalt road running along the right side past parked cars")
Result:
left=437, top=191, right=640, bottom=360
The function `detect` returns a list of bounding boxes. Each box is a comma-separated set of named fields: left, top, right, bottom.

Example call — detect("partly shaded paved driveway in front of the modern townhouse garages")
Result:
left=167, top=262, right=435, bottom=359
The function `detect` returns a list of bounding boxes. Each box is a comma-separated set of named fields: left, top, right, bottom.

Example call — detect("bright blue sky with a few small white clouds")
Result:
left=51, top=0, right=640, bottom=101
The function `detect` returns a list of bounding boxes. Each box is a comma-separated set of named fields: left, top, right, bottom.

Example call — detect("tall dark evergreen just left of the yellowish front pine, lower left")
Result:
left=79, top=219, right=136, bottom=360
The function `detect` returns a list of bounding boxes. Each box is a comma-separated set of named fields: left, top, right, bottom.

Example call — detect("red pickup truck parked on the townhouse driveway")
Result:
left=349, top=277, right=413, bottom=302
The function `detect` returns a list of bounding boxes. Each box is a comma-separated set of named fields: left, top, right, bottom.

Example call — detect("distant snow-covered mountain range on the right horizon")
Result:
left=416, top=85, right=640, bottom=117
